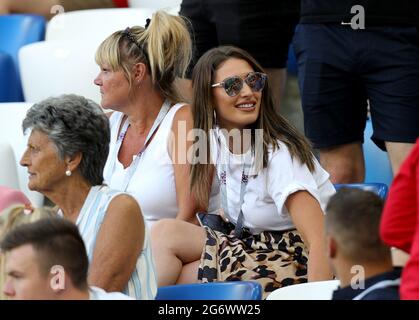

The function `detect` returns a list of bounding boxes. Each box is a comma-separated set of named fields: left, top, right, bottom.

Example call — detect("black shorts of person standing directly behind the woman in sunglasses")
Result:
left=180, top=0, right=299, bottom=73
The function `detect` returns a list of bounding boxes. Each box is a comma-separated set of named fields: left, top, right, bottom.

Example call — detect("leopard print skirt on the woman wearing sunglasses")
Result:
left=198, top=227, right=308, bottom=299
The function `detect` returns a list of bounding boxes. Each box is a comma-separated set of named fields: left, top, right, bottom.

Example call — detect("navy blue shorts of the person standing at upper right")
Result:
left=294, top=24, right=419, bottom=149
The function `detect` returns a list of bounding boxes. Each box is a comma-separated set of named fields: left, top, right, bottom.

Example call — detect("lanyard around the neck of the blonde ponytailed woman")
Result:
left=109, top=100, right=170, bottom=191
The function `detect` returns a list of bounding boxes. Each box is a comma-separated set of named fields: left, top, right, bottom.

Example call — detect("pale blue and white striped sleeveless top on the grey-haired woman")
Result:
left=58, top=185, right=157, bottom=300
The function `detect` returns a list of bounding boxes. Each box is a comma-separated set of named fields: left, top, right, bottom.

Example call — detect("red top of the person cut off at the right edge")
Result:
left=380, top=139, right=419, bottom=300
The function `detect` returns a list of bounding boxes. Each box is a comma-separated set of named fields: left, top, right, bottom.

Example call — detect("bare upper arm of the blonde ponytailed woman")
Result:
left=169, top=105, right=198, bottom=225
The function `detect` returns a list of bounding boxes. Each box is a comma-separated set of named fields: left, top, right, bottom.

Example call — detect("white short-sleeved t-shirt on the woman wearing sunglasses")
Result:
left=211, top=130, right=335, bottom=234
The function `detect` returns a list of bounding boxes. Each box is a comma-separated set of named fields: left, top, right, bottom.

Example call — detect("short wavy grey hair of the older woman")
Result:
left=22, top=94, right=110, bottom=186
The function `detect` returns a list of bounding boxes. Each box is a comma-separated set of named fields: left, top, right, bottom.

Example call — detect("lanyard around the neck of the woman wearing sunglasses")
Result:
left=217, top=130, right=251, bottom=238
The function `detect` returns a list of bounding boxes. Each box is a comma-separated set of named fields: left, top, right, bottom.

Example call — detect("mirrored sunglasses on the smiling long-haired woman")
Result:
left=211, top=72, right=267, bottom=97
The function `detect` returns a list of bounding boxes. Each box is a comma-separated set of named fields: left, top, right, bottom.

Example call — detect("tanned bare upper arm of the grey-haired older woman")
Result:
left=88, top=195, right=145, bottom=292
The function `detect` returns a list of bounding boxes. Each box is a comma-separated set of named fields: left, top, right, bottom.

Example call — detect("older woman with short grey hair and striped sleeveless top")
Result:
left=20, top=95, right=156, bottom=299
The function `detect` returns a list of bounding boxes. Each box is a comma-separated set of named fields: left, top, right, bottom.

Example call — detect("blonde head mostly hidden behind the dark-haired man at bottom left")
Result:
left=0, top=205, right=56, bottom=300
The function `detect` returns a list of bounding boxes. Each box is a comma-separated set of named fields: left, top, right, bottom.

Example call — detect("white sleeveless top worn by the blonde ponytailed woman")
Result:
left=104, top=103, right=219, bottom=228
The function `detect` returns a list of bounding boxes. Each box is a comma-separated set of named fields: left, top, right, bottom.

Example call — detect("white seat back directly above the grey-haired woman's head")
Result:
left=19, top=41, right=101, bottom=103
